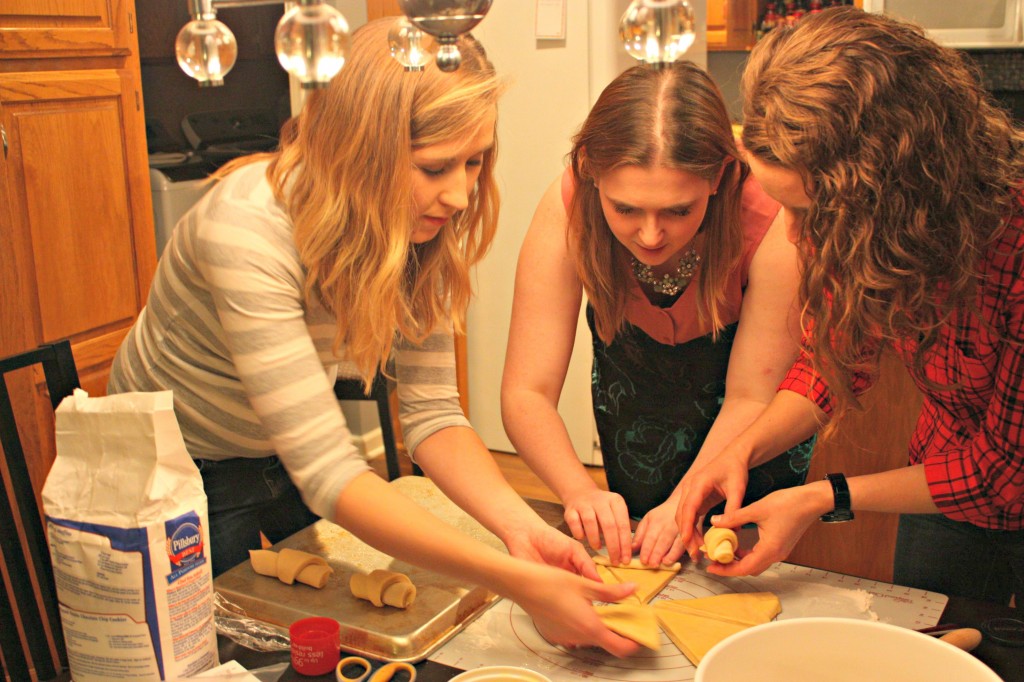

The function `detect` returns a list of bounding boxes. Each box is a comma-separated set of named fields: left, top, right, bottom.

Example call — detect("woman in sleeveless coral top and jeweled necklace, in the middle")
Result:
left=502, top=61, right=811, bottom=565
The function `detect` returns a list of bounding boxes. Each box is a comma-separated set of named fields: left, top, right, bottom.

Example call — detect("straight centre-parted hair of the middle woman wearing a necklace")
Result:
left=568, top=61, right=749, bottom=343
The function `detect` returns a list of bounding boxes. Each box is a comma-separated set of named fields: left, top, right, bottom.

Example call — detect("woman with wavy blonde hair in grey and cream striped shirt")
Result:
left=110, top=20, right=637, bottom=655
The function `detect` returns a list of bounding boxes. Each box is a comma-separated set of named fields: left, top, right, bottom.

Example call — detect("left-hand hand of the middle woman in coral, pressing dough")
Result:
left=562, top=489, right=633, bottom=563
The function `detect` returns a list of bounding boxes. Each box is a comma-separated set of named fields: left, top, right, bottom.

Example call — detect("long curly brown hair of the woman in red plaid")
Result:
left=742, top=7, right=1024, bottom=430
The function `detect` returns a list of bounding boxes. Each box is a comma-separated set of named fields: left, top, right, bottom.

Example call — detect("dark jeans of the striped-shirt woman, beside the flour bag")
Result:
left=196, top=457, right=319, bottom=578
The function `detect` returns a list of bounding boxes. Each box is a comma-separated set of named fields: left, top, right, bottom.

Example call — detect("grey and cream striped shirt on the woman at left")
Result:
left=109, top=162, right=469, bottom=520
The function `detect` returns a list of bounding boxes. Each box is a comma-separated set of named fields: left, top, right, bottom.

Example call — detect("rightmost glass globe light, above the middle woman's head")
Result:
left=618, top=0, right=696, bottom=68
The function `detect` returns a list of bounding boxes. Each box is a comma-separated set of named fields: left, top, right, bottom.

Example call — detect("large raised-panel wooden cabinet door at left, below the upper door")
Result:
left=0, top=69, right=156, bottom=393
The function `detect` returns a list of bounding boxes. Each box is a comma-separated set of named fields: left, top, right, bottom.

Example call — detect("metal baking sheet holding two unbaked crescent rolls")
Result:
left=214, top=476, right=506, bottom=663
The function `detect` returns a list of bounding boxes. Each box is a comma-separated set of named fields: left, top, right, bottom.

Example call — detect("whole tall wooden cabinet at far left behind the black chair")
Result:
left=0, top=0, right=156, bottom=497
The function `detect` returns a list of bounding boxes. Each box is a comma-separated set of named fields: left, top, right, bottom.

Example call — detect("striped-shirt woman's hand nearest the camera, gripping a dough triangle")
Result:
left=512, top=564, right=640, bottom=657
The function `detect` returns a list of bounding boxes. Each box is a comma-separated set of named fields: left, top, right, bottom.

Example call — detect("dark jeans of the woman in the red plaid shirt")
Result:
left=893, top=514, right=1024, bottom=607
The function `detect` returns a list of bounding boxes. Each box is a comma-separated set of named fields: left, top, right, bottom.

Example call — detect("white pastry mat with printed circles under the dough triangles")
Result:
left=430, top=562, right=948, bottom=682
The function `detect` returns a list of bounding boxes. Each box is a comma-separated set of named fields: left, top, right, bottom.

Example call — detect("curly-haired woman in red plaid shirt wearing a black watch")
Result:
left=678, top=7, right=1024, bottom=603
